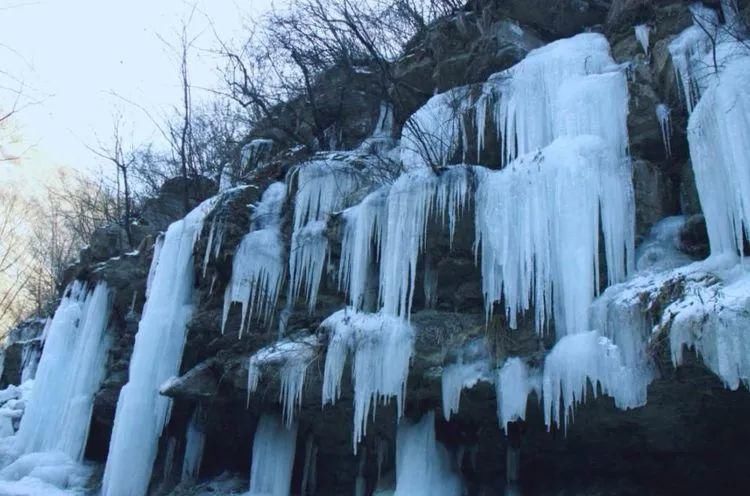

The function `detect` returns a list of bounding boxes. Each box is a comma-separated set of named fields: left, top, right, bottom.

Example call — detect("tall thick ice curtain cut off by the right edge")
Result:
left=688, top=55, right=750, bottom=255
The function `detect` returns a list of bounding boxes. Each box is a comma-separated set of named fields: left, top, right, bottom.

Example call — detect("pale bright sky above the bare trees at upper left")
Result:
left=0, top=0, right=278, bottom=190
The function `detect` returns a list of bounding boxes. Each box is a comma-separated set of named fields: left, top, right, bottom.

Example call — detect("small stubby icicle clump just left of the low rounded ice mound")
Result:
left=495, top=357, right=535, bottom=431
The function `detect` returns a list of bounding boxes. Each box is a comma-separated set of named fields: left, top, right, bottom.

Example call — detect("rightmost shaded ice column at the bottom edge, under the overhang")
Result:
left=393, top=412, right=463, bottom=496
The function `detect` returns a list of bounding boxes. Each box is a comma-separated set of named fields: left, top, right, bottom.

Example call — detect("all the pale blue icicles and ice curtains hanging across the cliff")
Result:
left=0, top=4, right=750, bottom=496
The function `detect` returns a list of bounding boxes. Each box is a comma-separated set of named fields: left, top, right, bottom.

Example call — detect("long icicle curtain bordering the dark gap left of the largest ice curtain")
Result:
left=380, top=167, right=470, bottom=316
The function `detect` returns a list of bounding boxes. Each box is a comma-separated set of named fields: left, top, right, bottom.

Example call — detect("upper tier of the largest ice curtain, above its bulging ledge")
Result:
left=476, top=33, right=627, bottom=164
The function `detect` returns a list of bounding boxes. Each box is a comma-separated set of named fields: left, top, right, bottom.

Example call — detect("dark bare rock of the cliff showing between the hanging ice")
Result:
left=8, top=0, right=750, bottom=496
